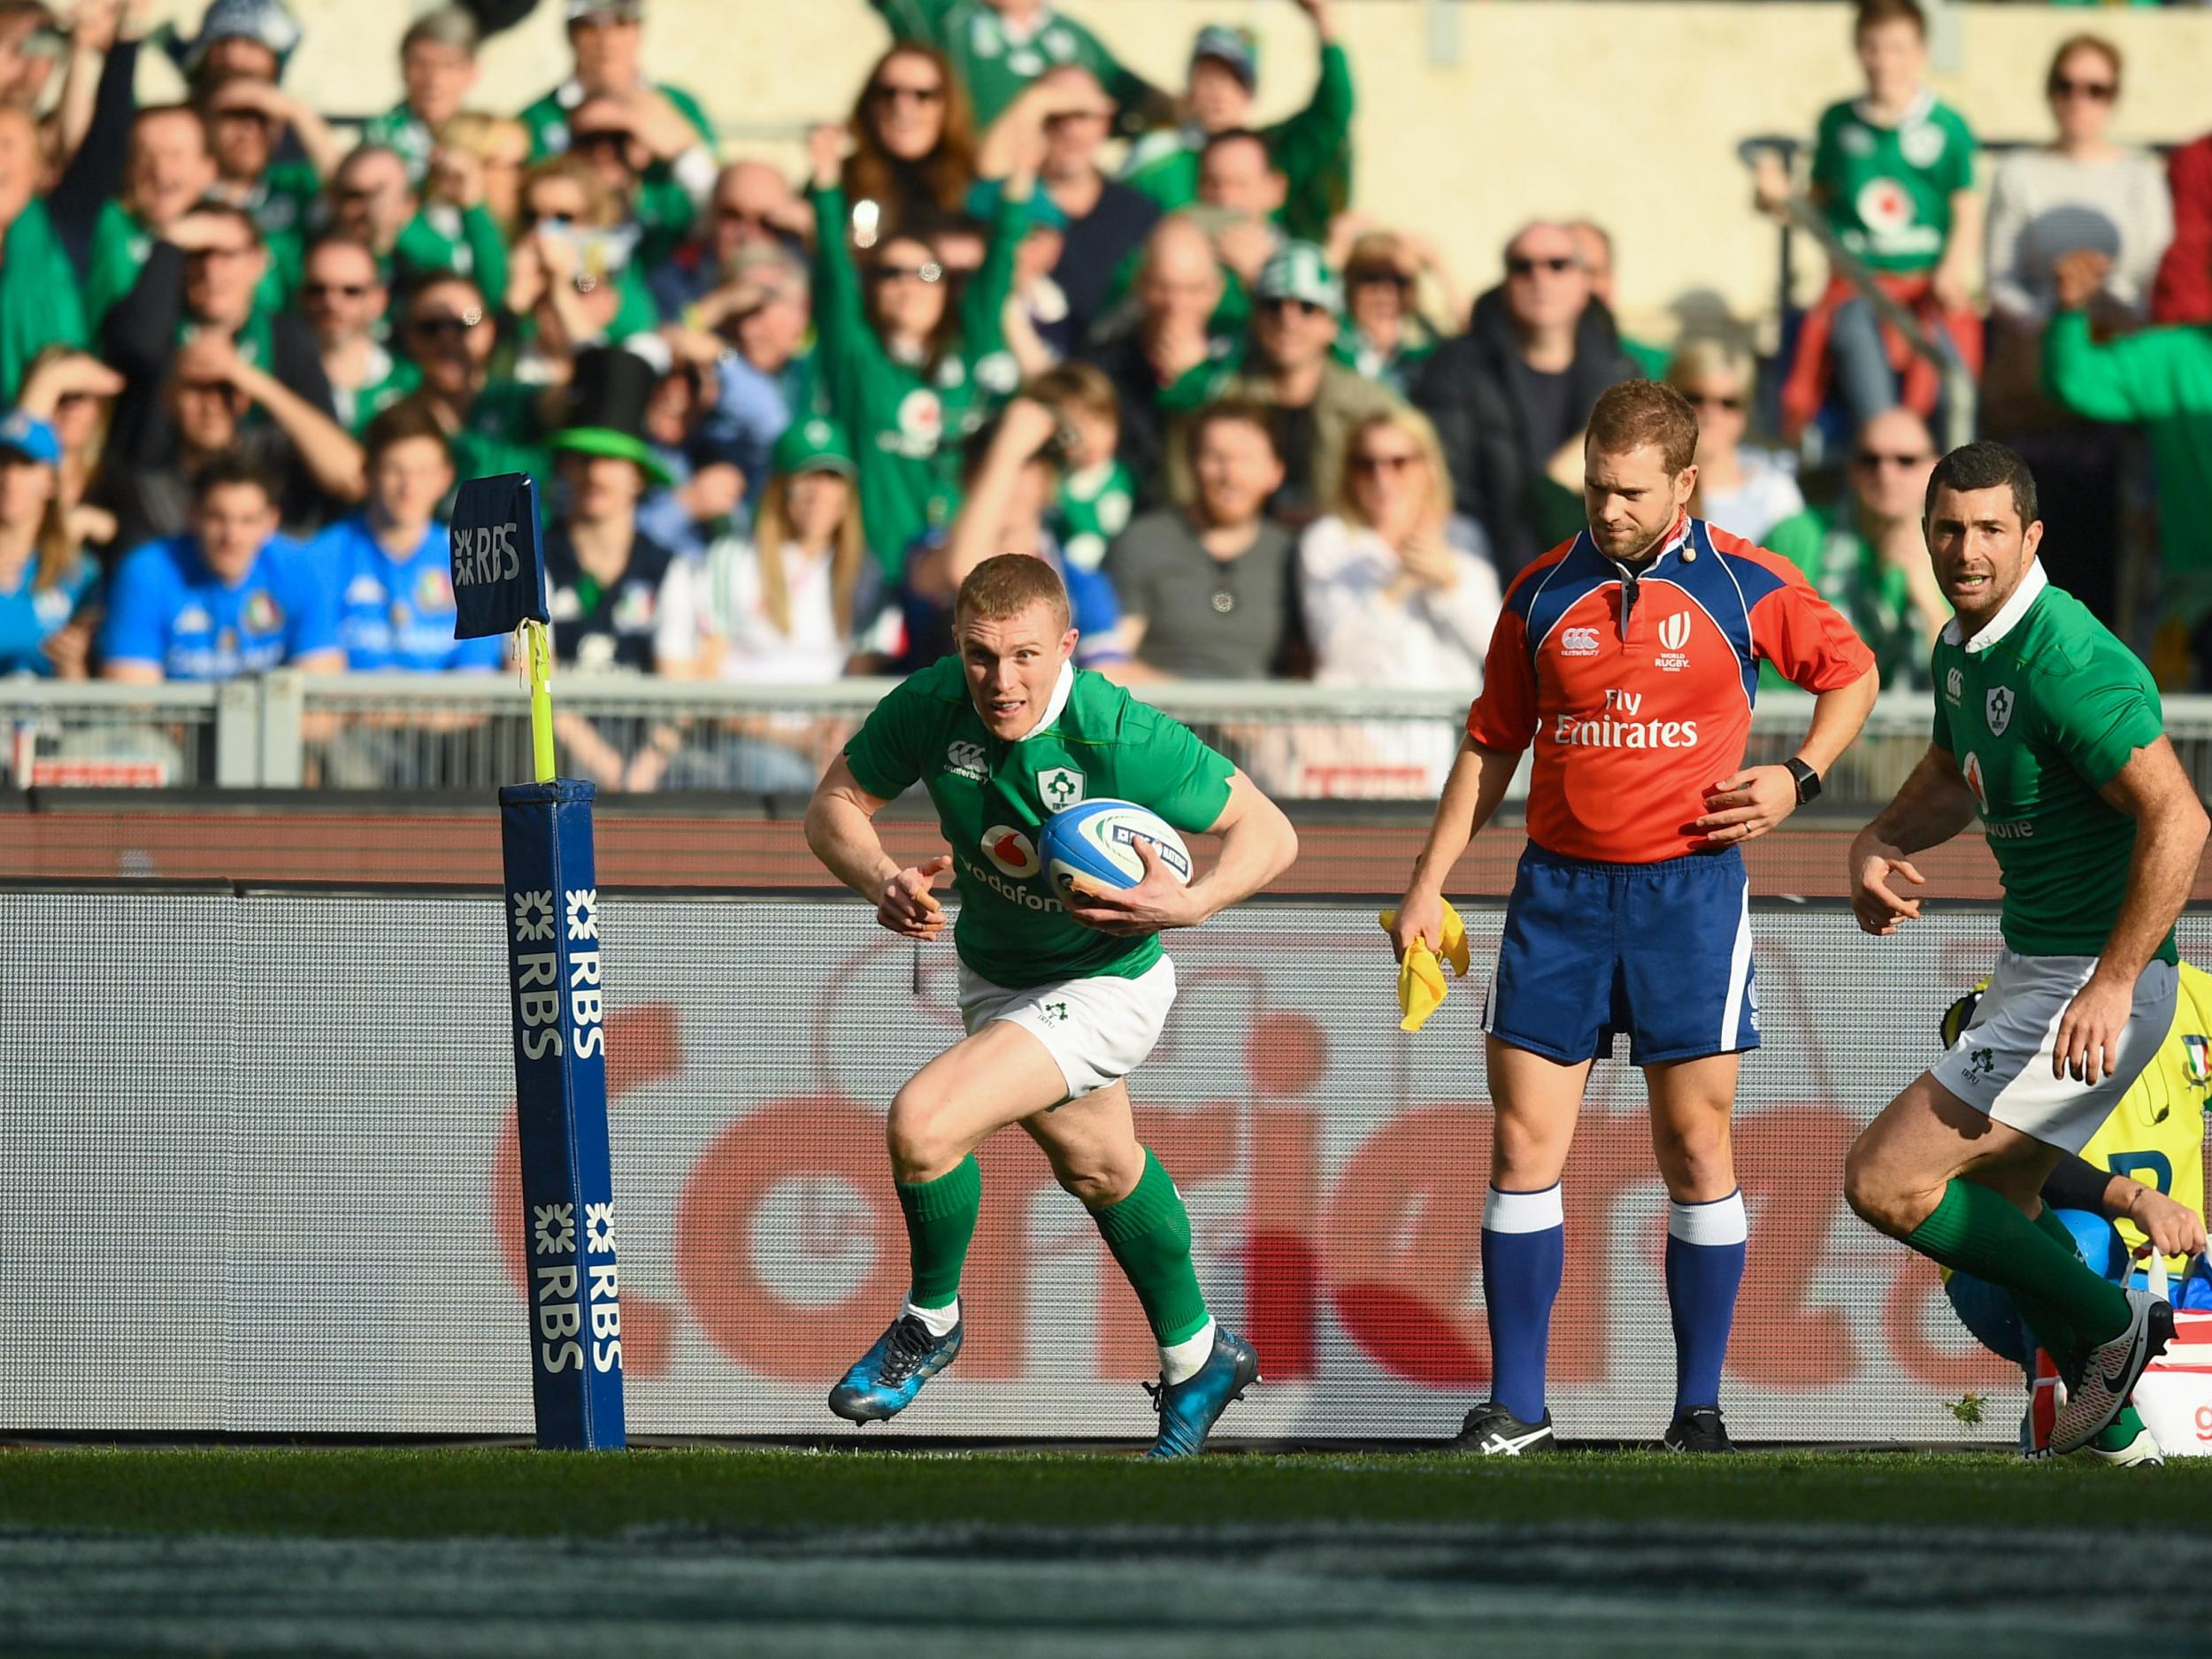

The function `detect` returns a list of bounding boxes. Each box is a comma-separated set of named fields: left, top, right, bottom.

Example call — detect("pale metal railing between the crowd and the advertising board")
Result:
left=17, top=672, right=2212, bottom=805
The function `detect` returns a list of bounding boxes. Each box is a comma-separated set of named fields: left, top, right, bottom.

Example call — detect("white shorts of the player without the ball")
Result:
left=1929, top=951, right=2181, bottom=1155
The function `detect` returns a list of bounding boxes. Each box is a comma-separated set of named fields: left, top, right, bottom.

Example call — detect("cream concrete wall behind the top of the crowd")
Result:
left=146, top=0, right=2212, bottom=339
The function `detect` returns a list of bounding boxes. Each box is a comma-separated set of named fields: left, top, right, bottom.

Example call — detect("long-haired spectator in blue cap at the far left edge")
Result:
left=0, top=410, right=93, bottom=680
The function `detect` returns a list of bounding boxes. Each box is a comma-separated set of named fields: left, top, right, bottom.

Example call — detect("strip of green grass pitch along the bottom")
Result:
left=0, top=1445, right=2212, bottom=1659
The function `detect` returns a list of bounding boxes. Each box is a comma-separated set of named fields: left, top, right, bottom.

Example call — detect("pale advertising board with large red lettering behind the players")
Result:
left=12, top=887, right=2212, bottom=1445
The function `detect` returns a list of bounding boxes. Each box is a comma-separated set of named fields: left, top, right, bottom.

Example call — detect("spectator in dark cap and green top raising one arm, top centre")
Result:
left=1124, top=0, right=1354, bottom=242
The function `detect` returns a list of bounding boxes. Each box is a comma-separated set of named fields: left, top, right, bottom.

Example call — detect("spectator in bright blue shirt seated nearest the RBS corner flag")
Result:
left=308, top=403, right=507, bottom=672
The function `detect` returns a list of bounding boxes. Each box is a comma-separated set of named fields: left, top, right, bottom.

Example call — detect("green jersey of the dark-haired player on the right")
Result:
left=1933, top=565, right=2179, bottom=963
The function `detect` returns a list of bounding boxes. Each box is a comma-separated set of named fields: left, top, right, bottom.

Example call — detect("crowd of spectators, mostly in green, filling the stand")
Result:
left=12, top=0, right=2212, bottom=787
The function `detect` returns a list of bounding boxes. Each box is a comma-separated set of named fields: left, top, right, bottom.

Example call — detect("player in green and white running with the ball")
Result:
left=808, top=553, right=1299, bottom=1458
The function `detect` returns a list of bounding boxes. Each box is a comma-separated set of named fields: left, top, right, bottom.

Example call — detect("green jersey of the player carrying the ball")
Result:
left=845, top=657, right=1234, bottom=989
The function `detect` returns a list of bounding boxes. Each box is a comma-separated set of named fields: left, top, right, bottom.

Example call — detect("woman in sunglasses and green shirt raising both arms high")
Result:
left=812, top=127, right=1035, bottom=582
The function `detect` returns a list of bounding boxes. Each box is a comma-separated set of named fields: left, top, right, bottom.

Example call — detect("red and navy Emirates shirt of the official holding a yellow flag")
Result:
left=1467, top=518, right=1874, bottom=865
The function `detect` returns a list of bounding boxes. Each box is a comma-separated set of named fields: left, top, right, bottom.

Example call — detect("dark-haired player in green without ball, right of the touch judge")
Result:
left=1843, top=442, right=2206, bottom=1454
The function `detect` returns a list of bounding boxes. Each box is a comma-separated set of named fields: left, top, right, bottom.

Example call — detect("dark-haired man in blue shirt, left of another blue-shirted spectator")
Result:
left=100, top=456, right=345, bottom=686
